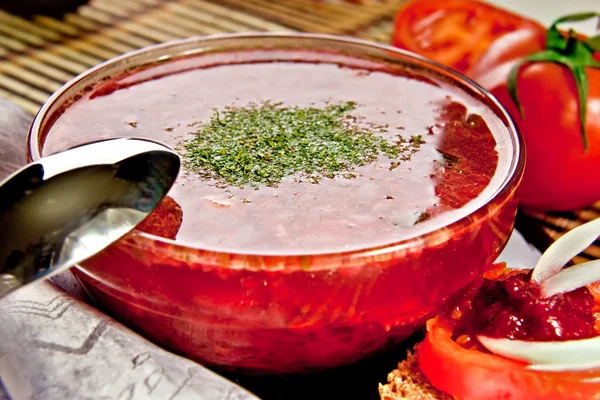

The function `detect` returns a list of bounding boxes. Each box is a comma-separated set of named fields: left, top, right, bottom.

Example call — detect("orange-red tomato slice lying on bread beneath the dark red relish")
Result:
left=418, top=317, right=600, bottom=400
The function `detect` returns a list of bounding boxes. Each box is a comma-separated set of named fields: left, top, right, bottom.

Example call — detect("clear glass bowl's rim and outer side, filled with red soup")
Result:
left=28, top=33, right=524, bottom=373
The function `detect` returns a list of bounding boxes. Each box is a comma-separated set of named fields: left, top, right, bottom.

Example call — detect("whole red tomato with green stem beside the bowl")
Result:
left=473, top=13, right=600, bottom=211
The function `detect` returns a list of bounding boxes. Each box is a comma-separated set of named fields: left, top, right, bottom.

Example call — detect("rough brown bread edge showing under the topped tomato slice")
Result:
left=379, top=345, right=454, bottom=400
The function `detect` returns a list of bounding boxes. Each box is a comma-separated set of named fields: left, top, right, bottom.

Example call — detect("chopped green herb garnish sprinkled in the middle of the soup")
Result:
left=182, top=101, right=423, bottom=188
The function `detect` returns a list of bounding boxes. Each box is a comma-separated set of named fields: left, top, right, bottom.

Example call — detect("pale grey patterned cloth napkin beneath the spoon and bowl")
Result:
left=0, top=99, right=258, bottom=400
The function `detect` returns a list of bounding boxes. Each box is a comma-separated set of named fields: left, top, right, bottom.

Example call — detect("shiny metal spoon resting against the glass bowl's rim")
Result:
left=0, top=138, right=180, bottom=298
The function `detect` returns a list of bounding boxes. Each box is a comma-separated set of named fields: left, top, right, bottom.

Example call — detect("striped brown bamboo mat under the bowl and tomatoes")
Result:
left=0, top=0, right=600, bottom=263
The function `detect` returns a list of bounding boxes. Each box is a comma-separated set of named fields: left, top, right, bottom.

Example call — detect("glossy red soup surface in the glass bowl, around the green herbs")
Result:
left=44, top=50, right=510, bottom=254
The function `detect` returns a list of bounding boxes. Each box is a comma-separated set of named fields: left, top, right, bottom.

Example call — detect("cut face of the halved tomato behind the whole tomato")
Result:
left=393, top=0, right=546, bottom=76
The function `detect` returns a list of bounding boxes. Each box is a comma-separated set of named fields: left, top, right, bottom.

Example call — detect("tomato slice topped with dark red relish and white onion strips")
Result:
left=416, top=212, right=600, bottom=400
